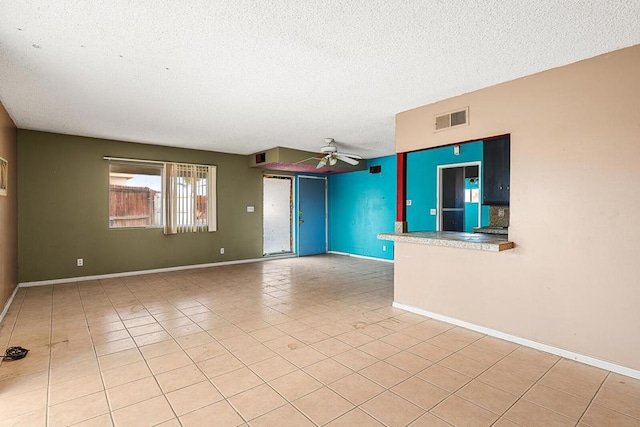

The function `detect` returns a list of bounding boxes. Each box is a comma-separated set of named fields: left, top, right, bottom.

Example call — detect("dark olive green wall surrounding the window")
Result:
left=18, top=130, right=262, bottom=282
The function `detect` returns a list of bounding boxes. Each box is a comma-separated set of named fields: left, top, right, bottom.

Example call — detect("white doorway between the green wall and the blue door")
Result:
left=262, top=175, right=293, bottom=256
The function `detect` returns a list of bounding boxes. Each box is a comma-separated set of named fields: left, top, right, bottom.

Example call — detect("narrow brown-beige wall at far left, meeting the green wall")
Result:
left=0, top=104, right=18, bottom=312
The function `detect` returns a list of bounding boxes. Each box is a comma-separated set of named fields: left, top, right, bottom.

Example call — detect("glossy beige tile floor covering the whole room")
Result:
left=0, top=255, right=640, bottom=427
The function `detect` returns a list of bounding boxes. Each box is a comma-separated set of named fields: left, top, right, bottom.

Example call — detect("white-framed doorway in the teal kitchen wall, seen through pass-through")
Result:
left=437, top=162, right=482, bottom=233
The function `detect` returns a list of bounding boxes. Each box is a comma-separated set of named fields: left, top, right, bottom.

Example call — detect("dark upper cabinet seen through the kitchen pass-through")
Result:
left=482, top=135, right=511, bottom=206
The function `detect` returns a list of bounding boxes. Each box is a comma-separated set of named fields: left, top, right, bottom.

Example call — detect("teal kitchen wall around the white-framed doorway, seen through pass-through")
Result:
left=407, top=141, right=489, bottom=231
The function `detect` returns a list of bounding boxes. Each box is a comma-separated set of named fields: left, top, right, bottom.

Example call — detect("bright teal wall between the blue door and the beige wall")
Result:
left=328, top=155, right=397, bottom=259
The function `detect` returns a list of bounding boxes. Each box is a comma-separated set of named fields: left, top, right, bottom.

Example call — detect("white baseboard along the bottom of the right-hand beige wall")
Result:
left=393, top=301, right=640, bottom=379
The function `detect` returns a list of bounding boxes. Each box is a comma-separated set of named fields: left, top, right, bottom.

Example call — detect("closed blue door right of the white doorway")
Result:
left=298, top=176, right=327, bottom=256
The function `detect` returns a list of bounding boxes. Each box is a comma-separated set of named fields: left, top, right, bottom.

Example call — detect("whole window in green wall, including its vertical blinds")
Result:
left=108, top=158, right=217, bottom=234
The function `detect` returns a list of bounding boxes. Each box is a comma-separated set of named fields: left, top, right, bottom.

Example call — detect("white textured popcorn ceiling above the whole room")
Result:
left=0, top=0, right=640, bottom=158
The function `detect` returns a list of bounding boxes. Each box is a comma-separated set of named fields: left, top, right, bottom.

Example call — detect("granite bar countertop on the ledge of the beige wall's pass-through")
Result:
left=378, top=231, right=514, bottom=252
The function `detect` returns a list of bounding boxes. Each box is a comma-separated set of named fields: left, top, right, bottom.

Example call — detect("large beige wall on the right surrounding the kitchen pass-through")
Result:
left=395, top=45, right=640, bottom=370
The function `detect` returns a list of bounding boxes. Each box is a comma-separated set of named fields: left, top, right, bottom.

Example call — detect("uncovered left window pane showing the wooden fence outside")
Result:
left=109, top=163, right=164, bottom=228
